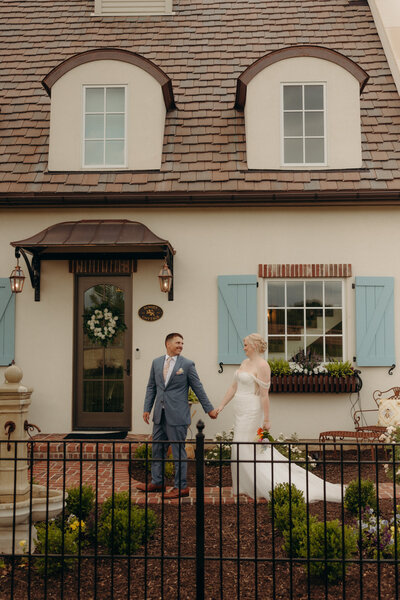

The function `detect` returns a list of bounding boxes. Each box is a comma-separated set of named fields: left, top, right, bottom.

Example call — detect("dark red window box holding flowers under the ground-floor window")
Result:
left=270, top=375, right=362, bottom=394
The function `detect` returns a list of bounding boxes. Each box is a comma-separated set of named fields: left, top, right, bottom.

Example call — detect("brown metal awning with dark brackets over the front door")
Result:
left=11, top=219, right=175, bottom=300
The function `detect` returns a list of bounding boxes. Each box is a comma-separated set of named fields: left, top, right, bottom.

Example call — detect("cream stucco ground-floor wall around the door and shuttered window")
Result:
left=0, top=208, right=400, bottom=437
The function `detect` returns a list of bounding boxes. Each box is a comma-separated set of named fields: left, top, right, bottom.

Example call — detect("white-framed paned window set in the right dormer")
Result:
left=282, top=83, right=326, bottom=165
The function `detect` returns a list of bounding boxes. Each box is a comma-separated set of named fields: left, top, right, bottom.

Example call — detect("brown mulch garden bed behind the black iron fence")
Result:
left=0, top=452, right=400, bottom=600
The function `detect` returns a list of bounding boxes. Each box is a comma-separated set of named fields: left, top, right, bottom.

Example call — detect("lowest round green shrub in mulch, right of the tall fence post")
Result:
left=299, top=519, right=357, bottom=583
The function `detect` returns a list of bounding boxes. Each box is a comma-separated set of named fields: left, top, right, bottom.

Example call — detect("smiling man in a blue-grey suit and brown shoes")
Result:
left=136, top=333, right=217, bottom=499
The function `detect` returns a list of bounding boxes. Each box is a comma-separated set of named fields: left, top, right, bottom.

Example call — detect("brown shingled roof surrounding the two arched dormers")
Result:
left=0, top=0, right=400, bottom=205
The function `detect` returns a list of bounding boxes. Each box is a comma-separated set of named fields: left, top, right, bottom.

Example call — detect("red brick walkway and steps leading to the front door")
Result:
left=28, top=435, right=400, bottom=505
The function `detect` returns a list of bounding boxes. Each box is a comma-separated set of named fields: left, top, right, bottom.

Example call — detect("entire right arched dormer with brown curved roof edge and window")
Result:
left=236, top=45, right=368, bottom=170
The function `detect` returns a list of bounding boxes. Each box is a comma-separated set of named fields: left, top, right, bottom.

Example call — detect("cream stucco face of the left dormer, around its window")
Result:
left=49, top=60, right=166, bottom=171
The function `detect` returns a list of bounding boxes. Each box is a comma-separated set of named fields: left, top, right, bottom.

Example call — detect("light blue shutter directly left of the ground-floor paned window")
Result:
left=218, top=275, right=257, bottom=365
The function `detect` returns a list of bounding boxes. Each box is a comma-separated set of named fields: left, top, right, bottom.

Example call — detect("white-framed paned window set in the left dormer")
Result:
left=83, top=86, right=126, bottom=167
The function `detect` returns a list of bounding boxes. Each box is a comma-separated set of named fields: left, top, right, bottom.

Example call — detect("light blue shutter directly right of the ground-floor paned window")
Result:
left=356, top=277, right=396, bottom=367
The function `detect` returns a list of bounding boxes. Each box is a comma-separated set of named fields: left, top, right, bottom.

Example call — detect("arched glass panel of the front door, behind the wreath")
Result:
left=83, top=283, right=126, bottom=413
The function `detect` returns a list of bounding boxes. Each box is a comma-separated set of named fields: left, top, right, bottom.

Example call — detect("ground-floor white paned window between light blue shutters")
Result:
left=266, top=279, right=344, bottom=362
